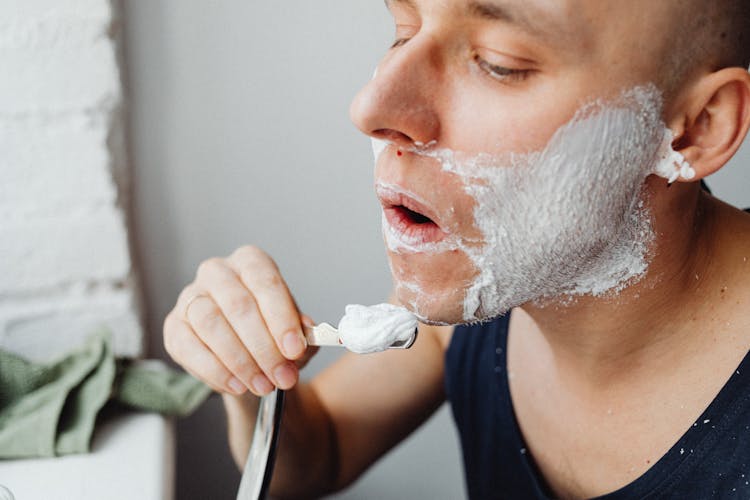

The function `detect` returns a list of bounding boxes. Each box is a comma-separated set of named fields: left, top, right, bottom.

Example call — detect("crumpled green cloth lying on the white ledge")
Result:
left=0, top=333, right=210, bottom=459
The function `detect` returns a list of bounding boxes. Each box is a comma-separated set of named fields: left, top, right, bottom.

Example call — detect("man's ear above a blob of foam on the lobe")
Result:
left=670, top=67, right=750, bottom=181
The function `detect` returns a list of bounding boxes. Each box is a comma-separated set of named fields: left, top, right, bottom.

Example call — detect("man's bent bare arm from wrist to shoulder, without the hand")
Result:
left=224, top=325, right=451, bottom=498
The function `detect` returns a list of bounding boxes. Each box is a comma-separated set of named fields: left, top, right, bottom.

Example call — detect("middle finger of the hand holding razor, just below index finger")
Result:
left=197, top=262, right=298, bottom=389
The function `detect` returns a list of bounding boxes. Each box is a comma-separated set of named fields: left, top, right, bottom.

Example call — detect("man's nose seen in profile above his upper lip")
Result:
left=349, top=35, right=440, bottom=147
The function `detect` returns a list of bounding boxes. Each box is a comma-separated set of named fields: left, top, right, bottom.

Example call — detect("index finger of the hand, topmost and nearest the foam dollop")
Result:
left=229, top=250, right=307, bottom=359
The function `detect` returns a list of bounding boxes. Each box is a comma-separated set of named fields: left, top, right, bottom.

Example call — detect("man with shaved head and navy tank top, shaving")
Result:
left=165, top=0, right=750, bottom=498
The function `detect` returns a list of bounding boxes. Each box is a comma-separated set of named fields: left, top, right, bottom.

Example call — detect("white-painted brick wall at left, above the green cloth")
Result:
left=0, top=0, right=142, bottom=359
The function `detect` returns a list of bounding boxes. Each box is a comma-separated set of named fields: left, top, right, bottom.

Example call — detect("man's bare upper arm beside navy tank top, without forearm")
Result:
left=312, top=325, right=453, bottom=490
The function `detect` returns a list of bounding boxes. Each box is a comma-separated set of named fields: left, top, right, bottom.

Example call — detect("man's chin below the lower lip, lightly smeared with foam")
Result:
left=388, top=246, right=477, bottom=325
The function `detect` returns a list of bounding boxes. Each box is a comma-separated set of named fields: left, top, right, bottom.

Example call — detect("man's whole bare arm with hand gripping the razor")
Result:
left=164, top=242, right=450, bottom=497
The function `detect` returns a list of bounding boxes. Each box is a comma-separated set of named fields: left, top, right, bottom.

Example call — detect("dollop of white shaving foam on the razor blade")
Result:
left=338, top=304, right=417, bottom=354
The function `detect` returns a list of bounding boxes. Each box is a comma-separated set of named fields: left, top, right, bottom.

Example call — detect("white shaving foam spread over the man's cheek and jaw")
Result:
left=374, top=85, right=690, bottom=322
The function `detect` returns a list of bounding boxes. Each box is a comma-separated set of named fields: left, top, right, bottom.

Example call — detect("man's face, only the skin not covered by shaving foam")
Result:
left=351, top=0, right=672, bottom=323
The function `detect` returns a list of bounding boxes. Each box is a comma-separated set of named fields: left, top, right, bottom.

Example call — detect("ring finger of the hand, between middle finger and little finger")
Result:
left=187, top=296, right=280, bottom=395
